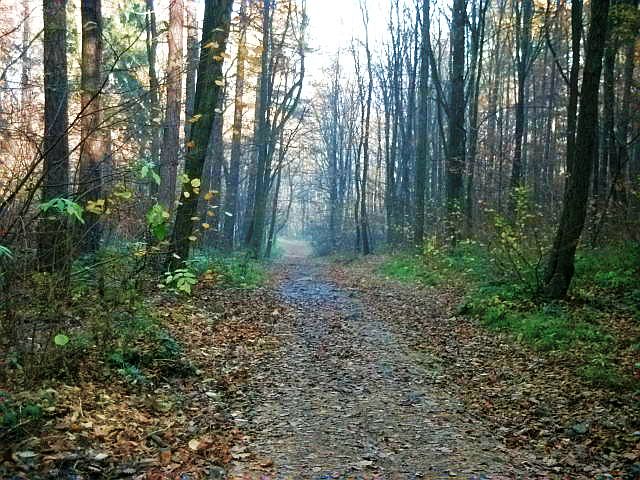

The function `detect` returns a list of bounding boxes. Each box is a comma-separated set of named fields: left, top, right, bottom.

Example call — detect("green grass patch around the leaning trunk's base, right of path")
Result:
left=379, top=242, right=640, bottom=389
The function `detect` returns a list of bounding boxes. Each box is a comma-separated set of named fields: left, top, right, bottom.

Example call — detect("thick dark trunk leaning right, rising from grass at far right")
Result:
left=545, top=0, right=609, bottom=298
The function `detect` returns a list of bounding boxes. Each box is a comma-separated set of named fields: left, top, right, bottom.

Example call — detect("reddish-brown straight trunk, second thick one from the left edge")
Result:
left=78, top=0, right=105, bottom=253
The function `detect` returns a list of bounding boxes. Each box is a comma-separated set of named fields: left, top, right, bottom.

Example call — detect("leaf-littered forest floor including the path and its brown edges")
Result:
left=0, top=246, right=640, bottom=480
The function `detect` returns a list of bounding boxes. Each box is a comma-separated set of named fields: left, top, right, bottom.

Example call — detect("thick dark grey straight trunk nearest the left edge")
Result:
left=38, top=0, right=70, bottom=270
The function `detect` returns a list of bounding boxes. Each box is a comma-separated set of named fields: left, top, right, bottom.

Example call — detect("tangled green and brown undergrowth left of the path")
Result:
left=0, top=243, right=195, bottom=439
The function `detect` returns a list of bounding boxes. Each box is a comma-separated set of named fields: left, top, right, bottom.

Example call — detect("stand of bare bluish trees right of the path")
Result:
left=304, top=0, right=640, bottom=297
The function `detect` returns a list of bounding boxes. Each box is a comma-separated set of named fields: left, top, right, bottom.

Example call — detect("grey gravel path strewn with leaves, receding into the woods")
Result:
left=232, top=256, right=514, bottom=479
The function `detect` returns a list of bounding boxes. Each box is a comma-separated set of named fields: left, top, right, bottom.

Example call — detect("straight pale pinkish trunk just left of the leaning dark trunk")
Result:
left=159, top=0, right=184, bottom=211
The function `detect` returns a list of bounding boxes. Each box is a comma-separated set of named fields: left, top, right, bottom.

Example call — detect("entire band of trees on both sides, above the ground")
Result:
left=0, top=0, right=640, bottom=297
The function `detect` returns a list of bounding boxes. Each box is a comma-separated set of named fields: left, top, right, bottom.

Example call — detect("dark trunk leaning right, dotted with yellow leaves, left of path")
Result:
left=168, top=0, right=233, bottom=266
